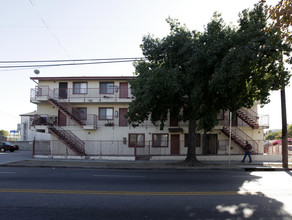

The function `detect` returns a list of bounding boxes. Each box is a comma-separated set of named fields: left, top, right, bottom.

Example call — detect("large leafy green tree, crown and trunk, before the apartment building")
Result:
left=127, top=5, right=289, bottom=164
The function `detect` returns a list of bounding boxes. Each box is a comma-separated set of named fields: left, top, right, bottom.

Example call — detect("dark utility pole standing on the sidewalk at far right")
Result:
left=281, top=86, right=288, bottom=169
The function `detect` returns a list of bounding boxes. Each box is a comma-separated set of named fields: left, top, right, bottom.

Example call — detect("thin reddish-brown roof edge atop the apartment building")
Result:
left=30, top=76, right=136, bottom=81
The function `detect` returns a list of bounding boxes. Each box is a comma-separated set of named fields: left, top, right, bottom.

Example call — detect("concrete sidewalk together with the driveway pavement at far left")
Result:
left=0, top=151, right=292, bottom=171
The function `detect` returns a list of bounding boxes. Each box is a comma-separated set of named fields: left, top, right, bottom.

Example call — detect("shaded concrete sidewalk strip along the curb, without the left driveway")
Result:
left=0, top=158, right=292, bottom=171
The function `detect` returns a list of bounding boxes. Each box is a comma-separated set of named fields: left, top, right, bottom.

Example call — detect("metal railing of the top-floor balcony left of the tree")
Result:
left=30, top=85, right=133, bottom=103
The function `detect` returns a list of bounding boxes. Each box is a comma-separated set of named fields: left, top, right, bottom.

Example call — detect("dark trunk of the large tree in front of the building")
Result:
left=185, top=120, right=199, bottom=164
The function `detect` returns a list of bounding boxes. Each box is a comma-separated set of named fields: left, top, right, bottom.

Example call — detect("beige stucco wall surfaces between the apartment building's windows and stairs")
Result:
left=33, top=77, right=263, bottom=155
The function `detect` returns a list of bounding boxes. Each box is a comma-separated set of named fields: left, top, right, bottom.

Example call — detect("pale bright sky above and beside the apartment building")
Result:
left=0, top=0, right=292, bottom=131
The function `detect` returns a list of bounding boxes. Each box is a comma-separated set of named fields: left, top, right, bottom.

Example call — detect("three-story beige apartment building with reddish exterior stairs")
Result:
left=30, top=76, right=268, bottom=159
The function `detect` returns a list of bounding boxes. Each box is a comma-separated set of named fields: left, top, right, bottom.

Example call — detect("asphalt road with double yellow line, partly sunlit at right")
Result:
left=0, top=167, right=292, bottom=220
